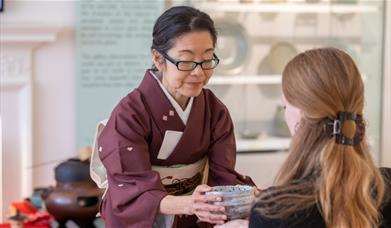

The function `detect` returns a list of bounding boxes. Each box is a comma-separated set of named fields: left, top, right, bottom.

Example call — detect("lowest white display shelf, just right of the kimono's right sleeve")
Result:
left=236, top=137, right=291, bottom=153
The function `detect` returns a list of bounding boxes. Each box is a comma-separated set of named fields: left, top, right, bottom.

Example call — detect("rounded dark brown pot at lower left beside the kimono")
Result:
left=45, top=159, right=102, bottom=228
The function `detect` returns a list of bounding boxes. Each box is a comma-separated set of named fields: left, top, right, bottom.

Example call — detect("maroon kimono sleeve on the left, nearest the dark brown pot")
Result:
left=98, top=95, right=167, bottom=227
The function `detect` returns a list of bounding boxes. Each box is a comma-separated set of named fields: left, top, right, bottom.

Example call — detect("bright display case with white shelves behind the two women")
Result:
left=188, top=0, right=387, bottom=180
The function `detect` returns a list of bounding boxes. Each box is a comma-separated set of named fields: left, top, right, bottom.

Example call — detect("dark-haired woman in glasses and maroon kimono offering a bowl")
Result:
left=97, top=6, right=253, bottom=227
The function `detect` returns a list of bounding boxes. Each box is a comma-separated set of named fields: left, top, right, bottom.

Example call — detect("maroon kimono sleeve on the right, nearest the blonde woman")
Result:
left=208, top=102, right=255, bottom=186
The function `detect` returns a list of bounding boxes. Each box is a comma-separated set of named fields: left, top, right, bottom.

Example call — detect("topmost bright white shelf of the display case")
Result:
left=196, top=1, right=380, bottom=14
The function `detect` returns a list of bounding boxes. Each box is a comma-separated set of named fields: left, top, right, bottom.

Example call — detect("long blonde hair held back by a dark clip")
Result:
left=259, top=48, right=385, bottom=228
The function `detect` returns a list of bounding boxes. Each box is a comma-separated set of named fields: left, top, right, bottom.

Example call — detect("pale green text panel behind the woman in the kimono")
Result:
left=75, top=0, right=164, bottom=148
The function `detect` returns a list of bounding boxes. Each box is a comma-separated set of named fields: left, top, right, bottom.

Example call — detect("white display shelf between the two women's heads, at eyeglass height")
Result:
left=209, top=74, right=281, bottom=85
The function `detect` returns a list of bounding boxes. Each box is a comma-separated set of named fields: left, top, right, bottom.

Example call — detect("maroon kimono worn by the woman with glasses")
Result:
left=98, top=71, right=254, bottom=228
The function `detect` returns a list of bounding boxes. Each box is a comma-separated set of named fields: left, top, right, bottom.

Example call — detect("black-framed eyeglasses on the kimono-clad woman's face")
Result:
left=160, top=52, right=220, bottom=71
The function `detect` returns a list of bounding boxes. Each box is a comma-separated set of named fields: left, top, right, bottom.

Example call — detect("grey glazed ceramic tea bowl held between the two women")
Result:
left=205, top=185, right=255, bottom=220
